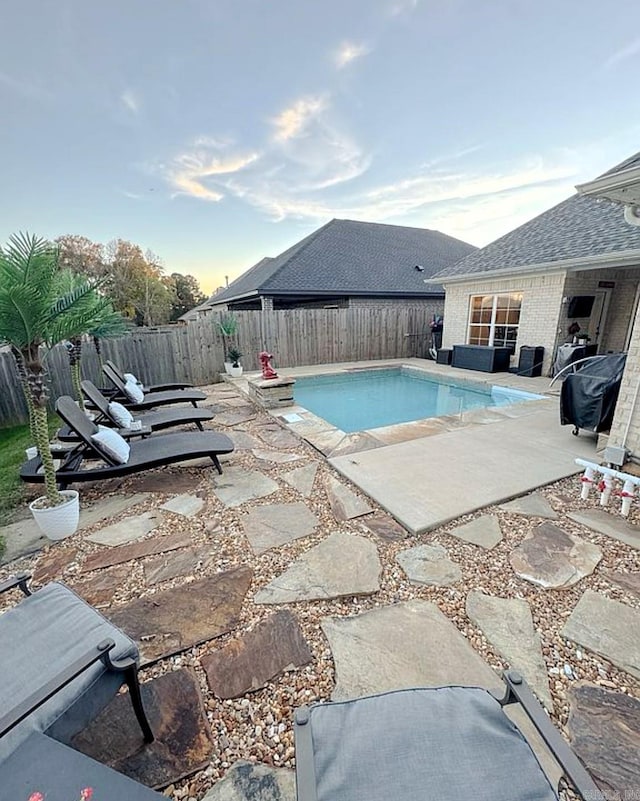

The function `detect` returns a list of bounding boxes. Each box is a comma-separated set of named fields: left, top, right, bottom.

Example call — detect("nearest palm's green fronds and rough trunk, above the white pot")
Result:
left=0, top=233, right=106, bottom=506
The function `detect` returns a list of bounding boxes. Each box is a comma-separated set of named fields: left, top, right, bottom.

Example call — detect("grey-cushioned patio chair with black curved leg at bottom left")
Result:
left=0, top=575, right=163, bottom=801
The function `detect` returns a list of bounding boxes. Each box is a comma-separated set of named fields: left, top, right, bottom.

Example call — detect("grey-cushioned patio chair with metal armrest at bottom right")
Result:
left=294, top=672, right=604, bottom=801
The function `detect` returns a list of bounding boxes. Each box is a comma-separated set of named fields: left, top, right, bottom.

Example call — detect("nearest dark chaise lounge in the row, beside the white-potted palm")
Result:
left=20, top=395, right=234, bottom=489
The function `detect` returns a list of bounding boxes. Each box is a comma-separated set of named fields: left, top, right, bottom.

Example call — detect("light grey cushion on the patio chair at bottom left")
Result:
left=0, top=582, right=138, bottom=760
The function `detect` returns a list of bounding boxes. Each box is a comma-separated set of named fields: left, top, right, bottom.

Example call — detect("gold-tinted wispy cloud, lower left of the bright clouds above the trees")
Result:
left=164, top=137, right=260, bottom=201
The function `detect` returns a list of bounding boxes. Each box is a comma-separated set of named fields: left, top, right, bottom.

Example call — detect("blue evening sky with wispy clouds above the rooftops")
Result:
left=0, top=0, right=640, bottom=293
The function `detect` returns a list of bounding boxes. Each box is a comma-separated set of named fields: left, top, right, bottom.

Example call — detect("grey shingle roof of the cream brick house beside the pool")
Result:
left=435, top=195, right=640, bottom=281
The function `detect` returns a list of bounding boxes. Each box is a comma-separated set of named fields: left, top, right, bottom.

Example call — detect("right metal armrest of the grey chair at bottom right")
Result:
left=498, top=670, right=605, bottom=801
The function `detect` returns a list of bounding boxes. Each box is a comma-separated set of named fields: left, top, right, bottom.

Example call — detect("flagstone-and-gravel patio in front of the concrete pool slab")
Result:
left=0, top=376, right=640, bottom=801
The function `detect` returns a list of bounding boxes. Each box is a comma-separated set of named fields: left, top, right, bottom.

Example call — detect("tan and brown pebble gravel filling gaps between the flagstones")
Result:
left=0, top=385, right=640, bottom=799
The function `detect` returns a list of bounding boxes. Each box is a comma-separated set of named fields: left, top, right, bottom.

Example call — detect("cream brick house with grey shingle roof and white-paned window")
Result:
left=434, top=154, right=640, bottom=374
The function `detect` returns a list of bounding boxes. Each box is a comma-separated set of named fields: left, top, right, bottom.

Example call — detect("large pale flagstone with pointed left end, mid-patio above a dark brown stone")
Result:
left=253, top=531, right=382, bottom=604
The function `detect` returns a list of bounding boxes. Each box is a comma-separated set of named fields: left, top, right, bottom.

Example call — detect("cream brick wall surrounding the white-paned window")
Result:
left=443, top=271, right=565, bottom=375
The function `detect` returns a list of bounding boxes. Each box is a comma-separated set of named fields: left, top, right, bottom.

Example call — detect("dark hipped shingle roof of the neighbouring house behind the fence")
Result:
left=211, top=220, right=475, bottom=303
